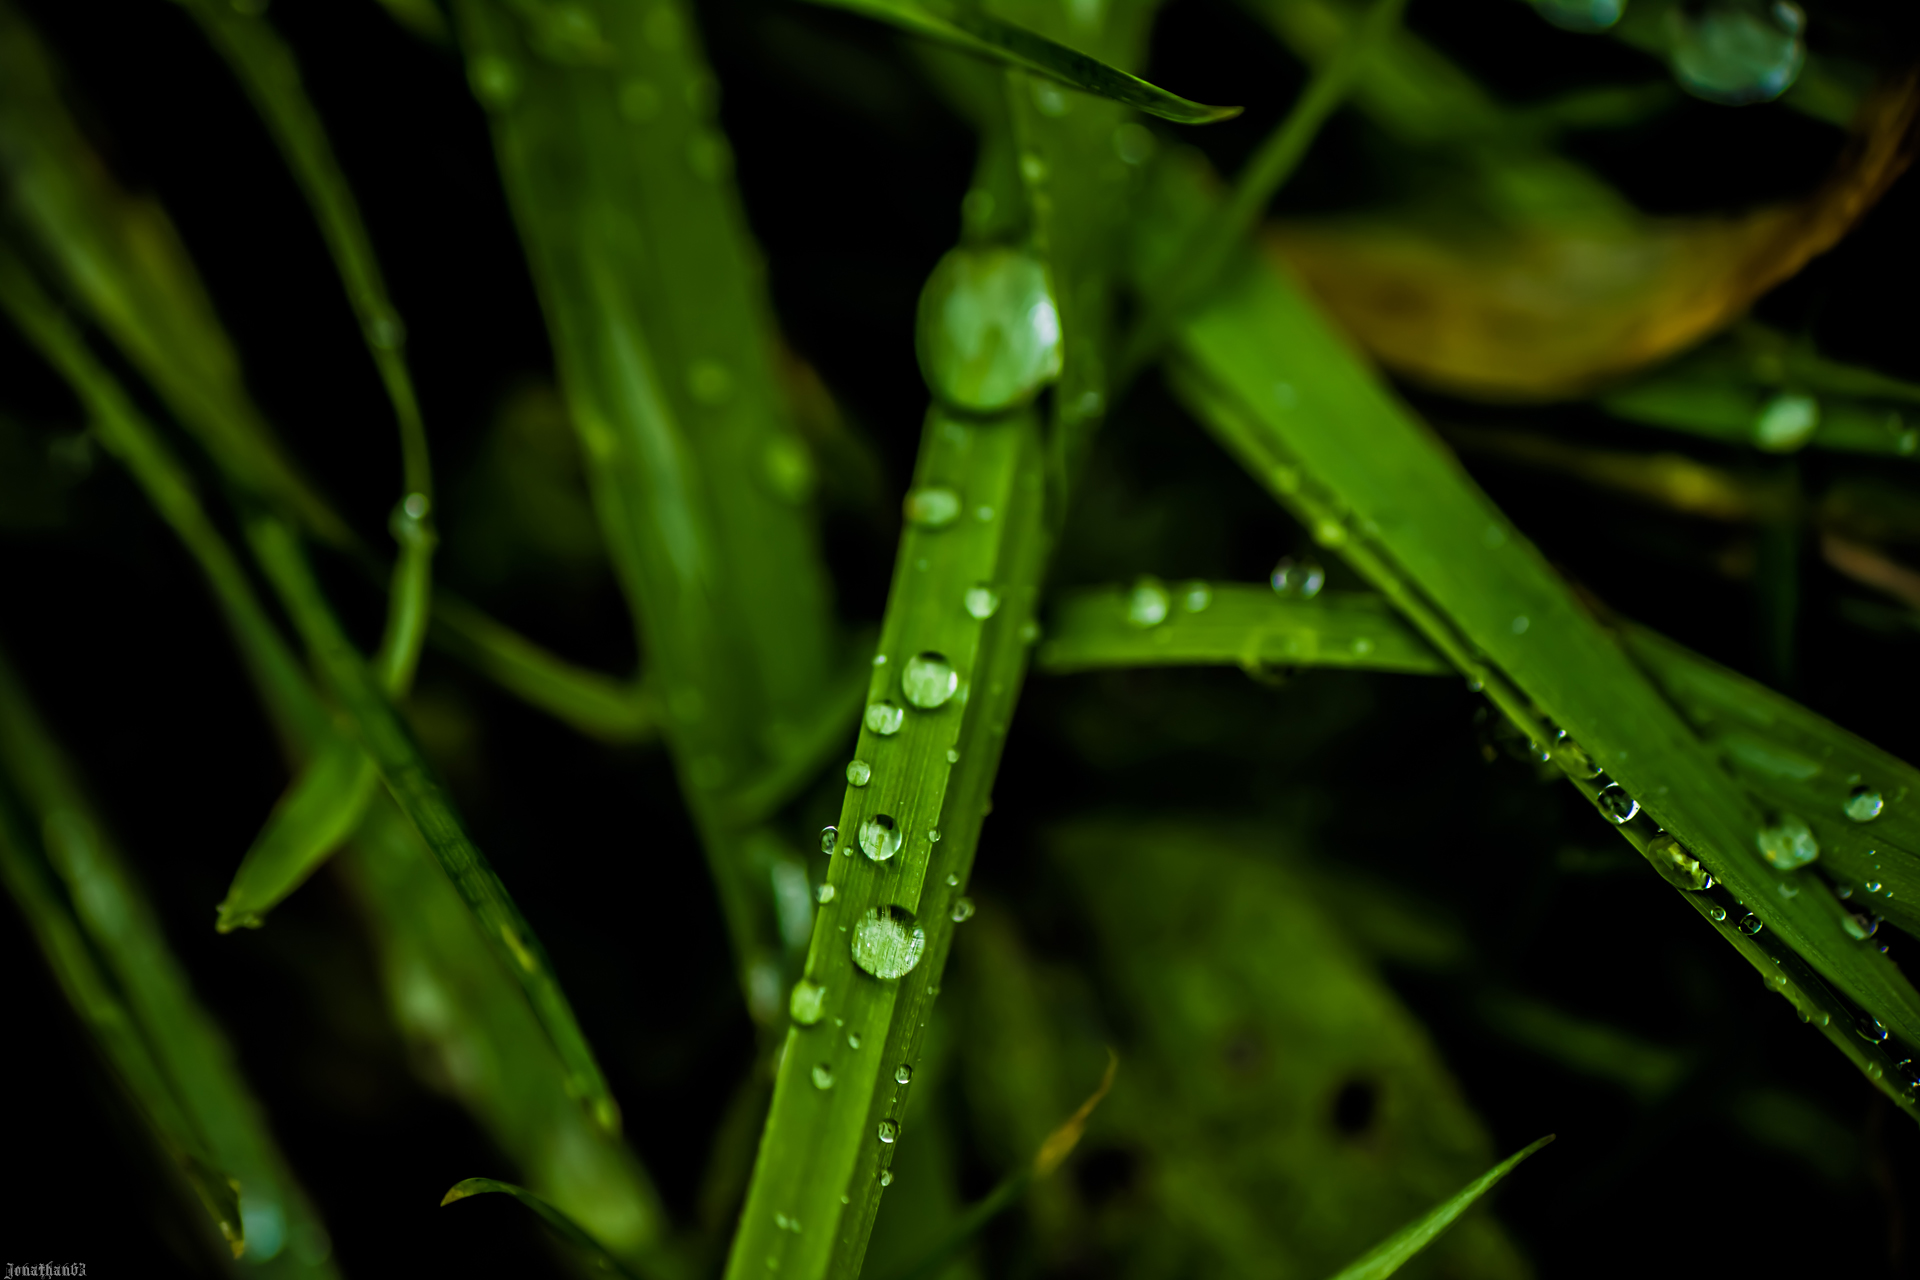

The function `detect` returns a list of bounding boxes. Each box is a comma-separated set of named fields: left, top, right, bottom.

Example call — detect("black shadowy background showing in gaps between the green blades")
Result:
left=0, top=0, right=1920, bottom=1276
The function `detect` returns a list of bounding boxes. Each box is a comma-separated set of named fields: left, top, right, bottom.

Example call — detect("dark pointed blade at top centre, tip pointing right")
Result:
left=814, top=0, right=1240, bottom=125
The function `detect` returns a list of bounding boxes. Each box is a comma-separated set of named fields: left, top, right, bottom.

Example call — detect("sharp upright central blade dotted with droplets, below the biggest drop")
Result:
left=728, top=411, right=1044, bottom=1276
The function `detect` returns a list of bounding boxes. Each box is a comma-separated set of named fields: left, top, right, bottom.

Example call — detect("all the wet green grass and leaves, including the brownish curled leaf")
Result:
left=0, top=0, right=1920, bottom=1276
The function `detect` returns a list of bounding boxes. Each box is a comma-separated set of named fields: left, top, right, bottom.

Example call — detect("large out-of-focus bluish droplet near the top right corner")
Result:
left=1667, top=0, right=1807, bottom=106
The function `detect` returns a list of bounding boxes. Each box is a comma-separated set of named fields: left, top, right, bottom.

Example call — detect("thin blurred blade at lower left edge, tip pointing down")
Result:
left=0, top=794, right=246, bottom=1257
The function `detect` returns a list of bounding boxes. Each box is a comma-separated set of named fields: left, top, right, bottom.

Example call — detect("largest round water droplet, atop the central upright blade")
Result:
left=914, top=247, right=1062, bottom=413
